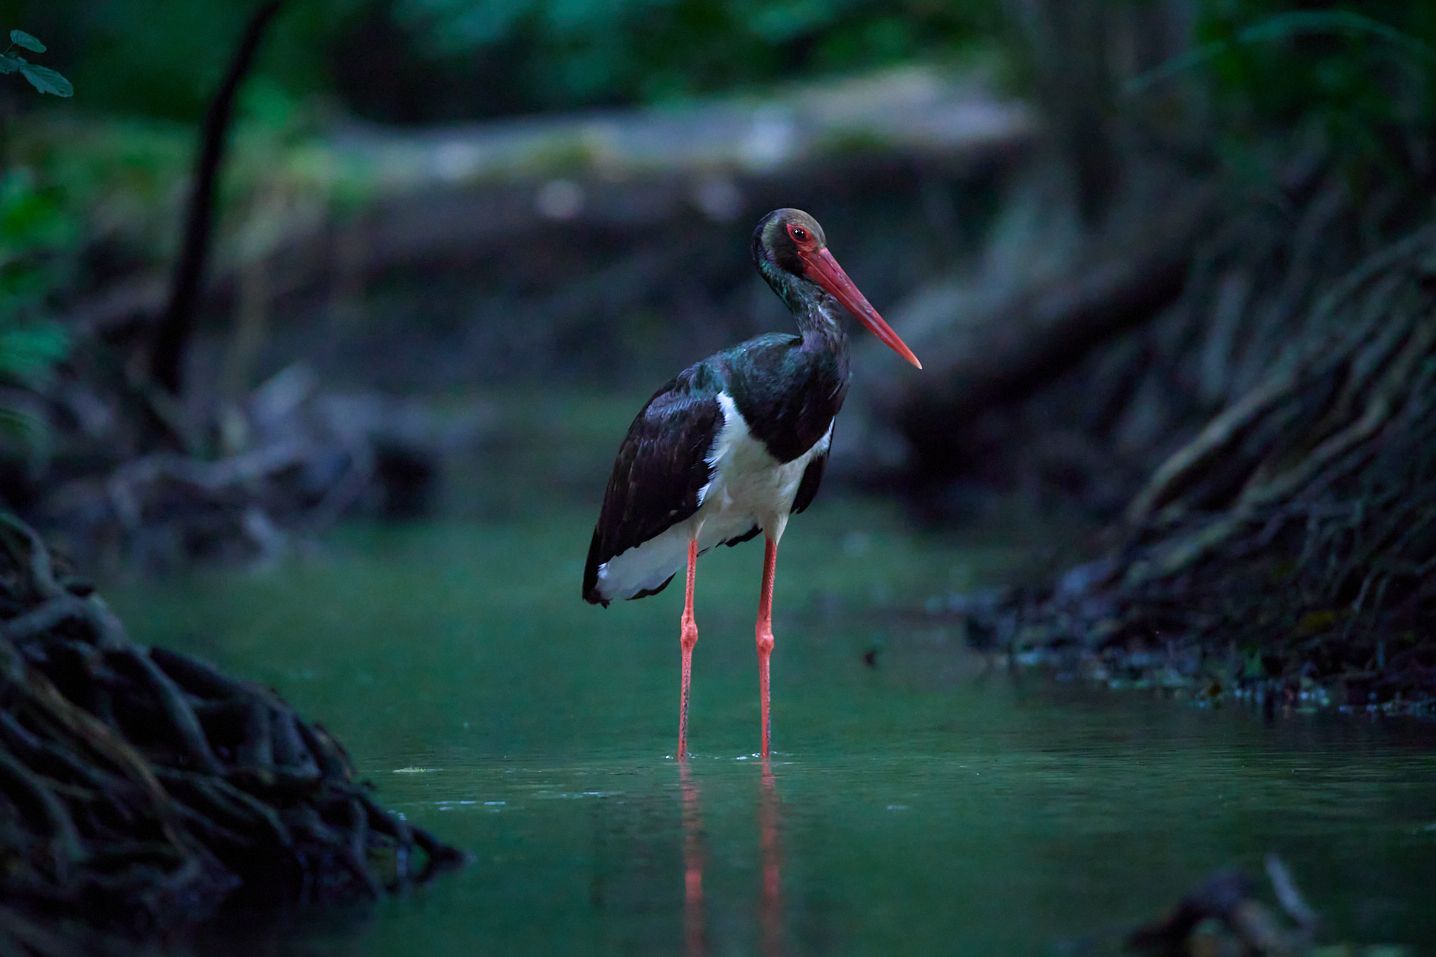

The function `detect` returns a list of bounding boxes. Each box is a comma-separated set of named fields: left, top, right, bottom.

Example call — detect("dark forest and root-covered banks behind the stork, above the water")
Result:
left=0, top=0, right=1436, bottom=686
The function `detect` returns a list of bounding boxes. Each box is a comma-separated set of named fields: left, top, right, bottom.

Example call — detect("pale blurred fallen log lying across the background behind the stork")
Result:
left=70, top=69, right=1038, bottom=338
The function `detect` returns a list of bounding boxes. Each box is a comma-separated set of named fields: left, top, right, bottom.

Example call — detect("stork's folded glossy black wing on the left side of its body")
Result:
left=583, top=364, right=722, bottom=604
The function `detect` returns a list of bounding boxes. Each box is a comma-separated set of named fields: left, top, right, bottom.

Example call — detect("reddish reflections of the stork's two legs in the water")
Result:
left=678, top=760, right=784, bottom=957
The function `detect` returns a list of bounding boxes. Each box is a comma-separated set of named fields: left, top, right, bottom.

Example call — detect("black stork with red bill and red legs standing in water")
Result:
left=583, top=210, right=922, bottom=760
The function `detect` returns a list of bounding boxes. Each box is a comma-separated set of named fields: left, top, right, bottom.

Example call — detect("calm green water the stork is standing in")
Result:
left=106, top=390, right=1436, bottom=957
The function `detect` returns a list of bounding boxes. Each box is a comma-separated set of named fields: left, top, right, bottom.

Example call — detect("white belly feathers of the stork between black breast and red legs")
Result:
left=599, top=392, right=833, bottom=599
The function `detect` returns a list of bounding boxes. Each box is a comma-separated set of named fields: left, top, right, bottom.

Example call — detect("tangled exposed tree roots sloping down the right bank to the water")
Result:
left=974, top=165, right=1436, bottom=707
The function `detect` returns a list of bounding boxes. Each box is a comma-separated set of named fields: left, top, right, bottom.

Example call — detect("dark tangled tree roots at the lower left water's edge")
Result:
left=0, top=516, right=462, bottom=956
